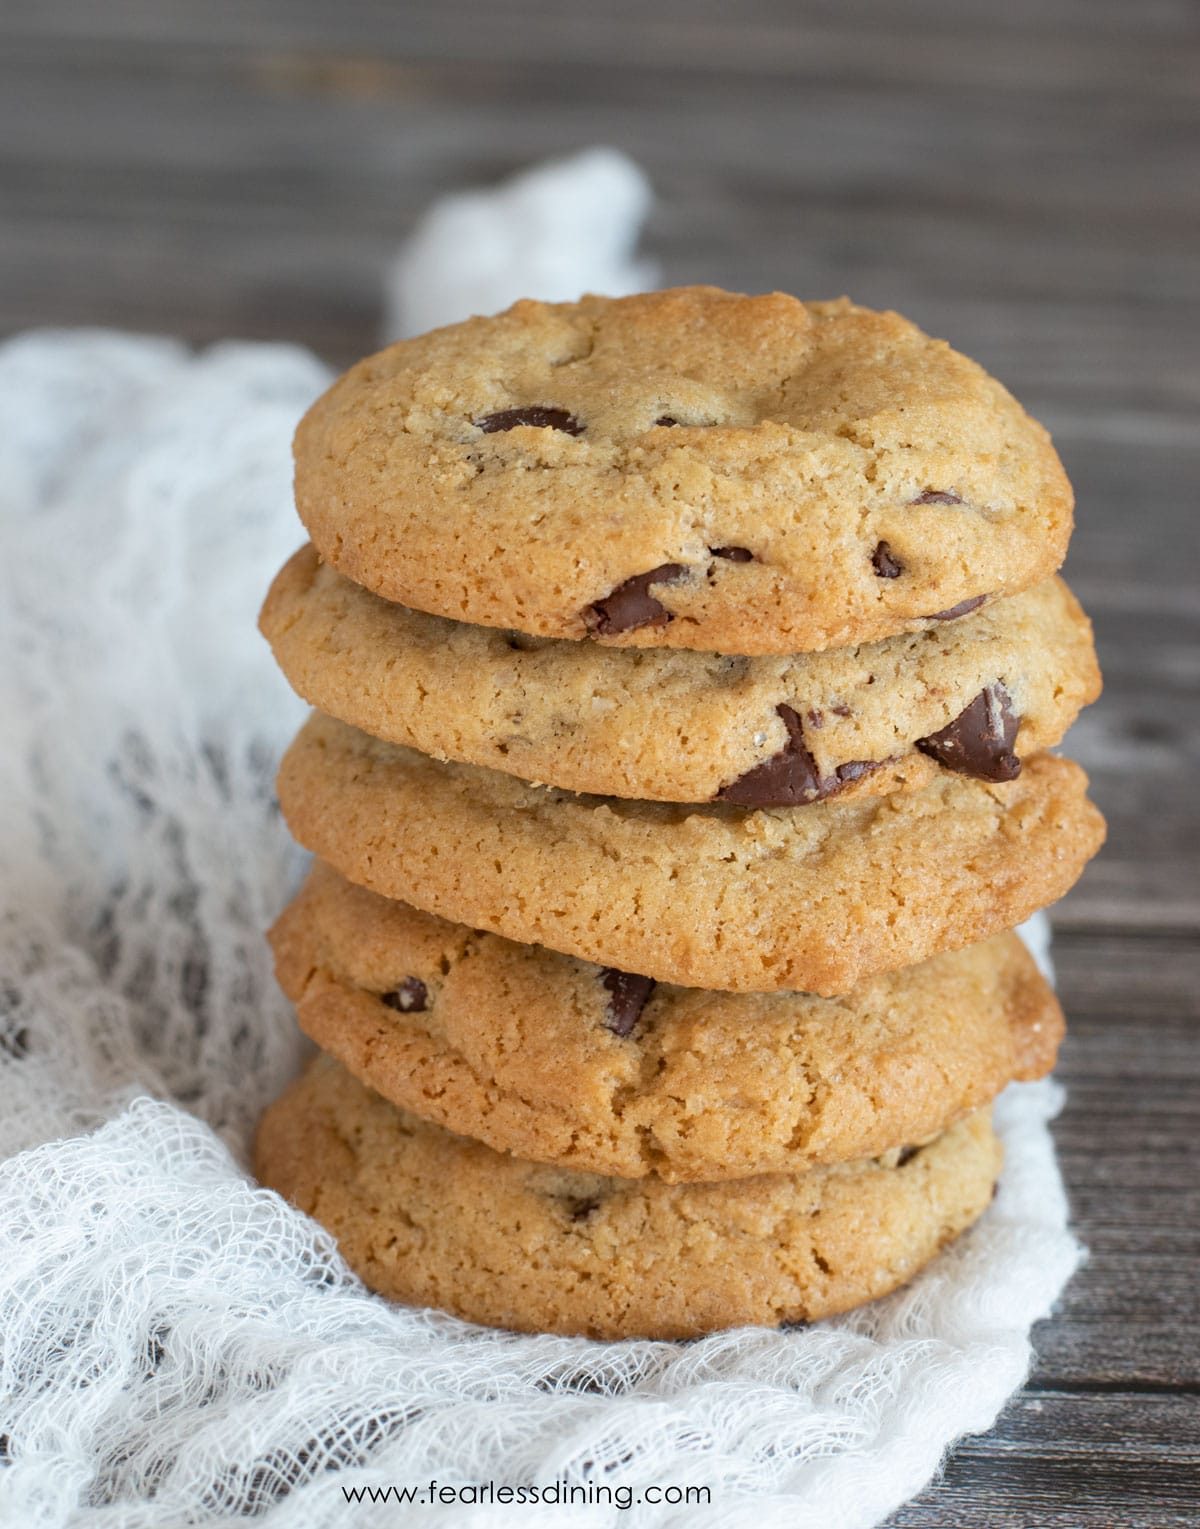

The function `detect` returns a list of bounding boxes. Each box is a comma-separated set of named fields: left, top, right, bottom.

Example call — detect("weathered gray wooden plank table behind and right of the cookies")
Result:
left=0, top=0, right=1200, bottom=1529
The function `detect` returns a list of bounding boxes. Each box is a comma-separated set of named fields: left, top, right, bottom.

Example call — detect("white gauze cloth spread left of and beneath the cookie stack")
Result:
left=0, top=146, right=1081, bottom=1529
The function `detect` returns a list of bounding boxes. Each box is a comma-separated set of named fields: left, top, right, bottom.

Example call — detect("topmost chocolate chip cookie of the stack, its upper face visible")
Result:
left=295, top=287, right=1072, bottom=653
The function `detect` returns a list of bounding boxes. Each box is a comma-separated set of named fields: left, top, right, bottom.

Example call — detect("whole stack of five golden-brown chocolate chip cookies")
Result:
left=257, top=287, right=1104, bottom=1336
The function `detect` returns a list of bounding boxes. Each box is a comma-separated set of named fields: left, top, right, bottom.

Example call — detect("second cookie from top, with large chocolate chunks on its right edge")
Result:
left=260, top=547, right=1101, bottom=806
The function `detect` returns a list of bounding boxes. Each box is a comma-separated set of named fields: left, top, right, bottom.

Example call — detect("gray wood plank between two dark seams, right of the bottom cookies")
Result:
left=1035, top=931, right=1200, bottom=1391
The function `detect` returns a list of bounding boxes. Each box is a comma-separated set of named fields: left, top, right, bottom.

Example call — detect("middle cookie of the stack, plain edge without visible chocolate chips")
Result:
left=278, top=714, right=1104, bottom=995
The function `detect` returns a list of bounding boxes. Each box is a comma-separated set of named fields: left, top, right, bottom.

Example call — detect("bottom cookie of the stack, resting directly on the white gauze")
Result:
left=255, top=1057, right=1001, bottom=1338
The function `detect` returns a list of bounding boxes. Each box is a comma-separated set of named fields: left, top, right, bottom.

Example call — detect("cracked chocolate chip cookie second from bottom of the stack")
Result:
left=271, top=864, right=1062, bottom=1182
